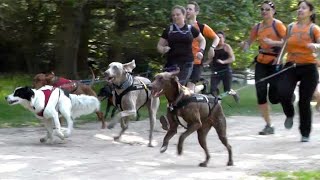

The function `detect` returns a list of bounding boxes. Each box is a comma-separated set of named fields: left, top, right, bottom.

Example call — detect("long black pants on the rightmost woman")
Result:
left=279, top=63, right=319, bottom=137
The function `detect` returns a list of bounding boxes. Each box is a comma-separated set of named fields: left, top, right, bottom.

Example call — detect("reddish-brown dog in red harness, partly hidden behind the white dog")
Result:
left=33, top=71, right=106, bottom=129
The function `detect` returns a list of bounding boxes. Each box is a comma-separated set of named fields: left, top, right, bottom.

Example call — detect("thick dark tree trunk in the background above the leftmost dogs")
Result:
left=55, top=1, right=86, bottom=79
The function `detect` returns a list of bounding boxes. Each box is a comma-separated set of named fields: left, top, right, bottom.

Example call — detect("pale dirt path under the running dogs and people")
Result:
left=0, top=113, right=320, bottom=180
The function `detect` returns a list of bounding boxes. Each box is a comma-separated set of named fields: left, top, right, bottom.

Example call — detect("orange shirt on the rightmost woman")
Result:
left=287, top=23, right=320, bottom=64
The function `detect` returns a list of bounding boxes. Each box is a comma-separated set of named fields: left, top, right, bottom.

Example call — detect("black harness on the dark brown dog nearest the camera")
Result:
left=169, top=94, right=221, bottom=129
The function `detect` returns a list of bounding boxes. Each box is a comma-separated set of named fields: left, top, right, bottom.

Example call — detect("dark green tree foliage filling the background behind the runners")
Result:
left=0, top=0, right=320, bottom=73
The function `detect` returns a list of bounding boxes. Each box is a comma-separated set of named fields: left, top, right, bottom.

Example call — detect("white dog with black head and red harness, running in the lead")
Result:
left=5, top=86, right=100, bottom=143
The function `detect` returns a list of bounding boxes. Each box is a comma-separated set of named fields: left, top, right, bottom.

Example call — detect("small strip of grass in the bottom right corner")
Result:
left=260, top=170, right=320, bottom=180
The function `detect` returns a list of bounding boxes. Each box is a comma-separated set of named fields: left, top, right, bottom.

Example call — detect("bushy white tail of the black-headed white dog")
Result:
left=70, top=94, right=100, bottom=119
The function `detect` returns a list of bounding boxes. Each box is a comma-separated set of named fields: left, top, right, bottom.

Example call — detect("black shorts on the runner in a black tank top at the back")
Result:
left=210, top=69, right=232, bottom=95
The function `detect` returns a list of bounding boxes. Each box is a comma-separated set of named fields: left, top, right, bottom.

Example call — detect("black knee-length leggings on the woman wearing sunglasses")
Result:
left=254, top=62, right=279, bottom=104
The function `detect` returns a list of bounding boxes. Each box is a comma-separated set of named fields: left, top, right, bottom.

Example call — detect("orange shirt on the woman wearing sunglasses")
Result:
left=250, top=19, right=286, bottom=64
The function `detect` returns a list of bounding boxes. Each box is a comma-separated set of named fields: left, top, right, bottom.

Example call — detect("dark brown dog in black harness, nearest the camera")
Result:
left=151, top=71, right=233, bottom=167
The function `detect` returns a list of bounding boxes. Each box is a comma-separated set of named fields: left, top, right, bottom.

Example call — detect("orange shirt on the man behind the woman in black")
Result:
left=192, top=22, right=216, bottom=64
